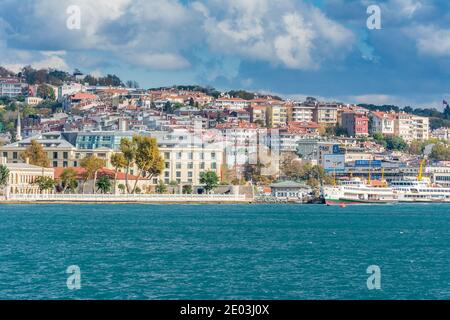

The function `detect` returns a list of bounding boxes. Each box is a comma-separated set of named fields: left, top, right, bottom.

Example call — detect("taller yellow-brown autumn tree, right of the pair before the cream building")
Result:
left=132, top=136, right=164, bottom=193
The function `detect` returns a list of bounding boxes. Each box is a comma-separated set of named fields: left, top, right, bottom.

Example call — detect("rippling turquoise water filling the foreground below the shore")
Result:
left=0, top=204, right=450, bottom=299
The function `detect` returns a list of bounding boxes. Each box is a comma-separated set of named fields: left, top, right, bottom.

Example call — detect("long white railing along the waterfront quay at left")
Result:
left=8, top=194, right=251, bottom=203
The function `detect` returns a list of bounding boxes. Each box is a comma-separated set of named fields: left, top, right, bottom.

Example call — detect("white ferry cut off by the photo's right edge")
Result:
left=390, top=177, right=450, bottom=202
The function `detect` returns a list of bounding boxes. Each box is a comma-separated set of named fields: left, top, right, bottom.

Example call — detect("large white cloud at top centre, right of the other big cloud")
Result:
left=193, top=0, right=354, bottom=70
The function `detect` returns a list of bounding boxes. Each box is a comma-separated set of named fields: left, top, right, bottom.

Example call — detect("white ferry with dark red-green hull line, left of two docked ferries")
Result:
left=322, top=178, right=397, bottom=205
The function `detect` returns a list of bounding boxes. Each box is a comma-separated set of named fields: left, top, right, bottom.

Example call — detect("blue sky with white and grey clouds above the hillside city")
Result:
left=0, top=0, right=450, bottom=108
